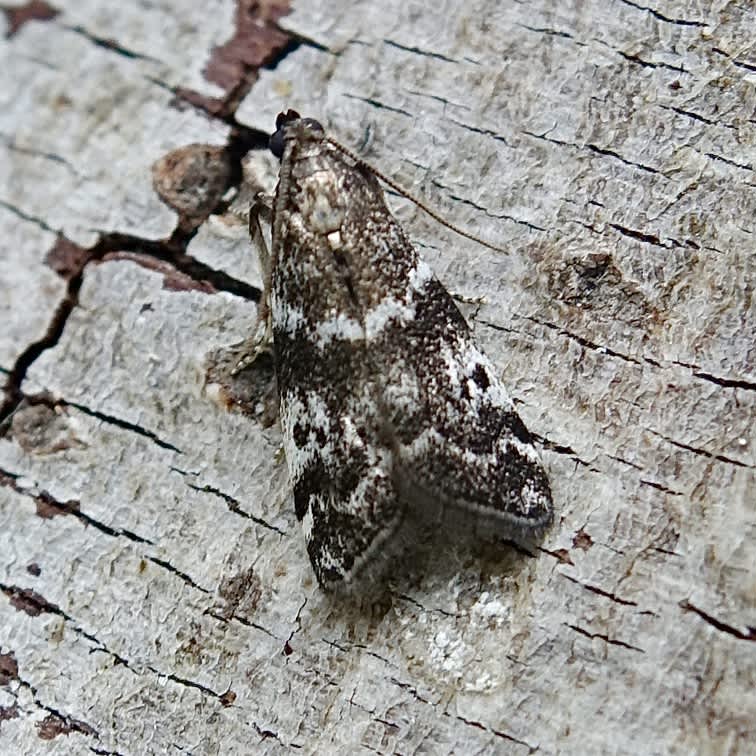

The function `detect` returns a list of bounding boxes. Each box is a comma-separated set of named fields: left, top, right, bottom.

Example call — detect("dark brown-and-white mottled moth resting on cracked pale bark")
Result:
left=250, top=110, right=553, bottom=588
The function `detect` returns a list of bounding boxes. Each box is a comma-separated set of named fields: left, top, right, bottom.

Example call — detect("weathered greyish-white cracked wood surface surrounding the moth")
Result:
left=0, top=0, right=756, bottom=754
